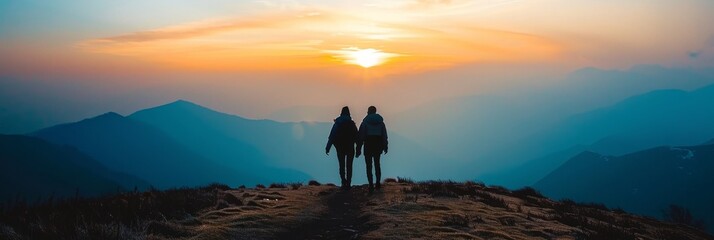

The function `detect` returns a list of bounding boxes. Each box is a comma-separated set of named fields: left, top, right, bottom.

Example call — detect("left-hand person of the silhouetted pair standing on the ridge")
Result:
left=325, top=107, right=357, bottom=190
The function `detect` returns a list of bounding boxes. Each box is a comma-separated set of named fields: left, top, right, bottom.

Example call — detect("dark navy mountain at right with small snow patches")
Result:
left=534, top=144, right=714, bottom=232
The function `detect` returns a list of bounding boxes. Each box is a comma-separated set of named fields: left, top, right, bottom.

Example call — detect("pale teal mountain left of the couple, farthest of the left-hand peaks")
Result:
left=128, top=100, right=322, bottom=182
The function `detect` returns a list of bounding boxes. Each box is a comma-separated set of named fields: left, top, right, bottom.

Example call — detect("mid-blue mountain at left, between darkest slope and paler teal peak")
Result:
left=33, top=113, right=265, bottom=188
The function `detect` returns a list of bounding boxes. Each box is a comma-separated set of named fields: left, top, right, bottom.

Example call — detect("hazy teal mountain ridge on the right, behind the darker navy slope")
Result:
left=478, top=85, right=714, bottom=187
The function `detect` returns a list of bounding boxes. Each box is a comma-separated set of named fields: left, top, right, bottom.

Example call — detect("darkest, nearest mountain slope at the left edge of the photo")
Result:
left=0, top=135, right=149, bottom=202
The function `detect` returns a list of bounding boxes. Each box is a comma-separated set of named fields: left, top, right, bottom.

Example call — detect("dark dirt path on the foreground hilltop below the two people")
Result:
left=279, top=186, right=371, bottom=239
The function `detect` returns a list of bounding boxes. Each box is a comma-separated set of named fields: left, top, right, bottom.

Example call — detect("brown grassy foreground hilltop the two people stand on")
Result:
left=0, top=181, right=713, bottom=240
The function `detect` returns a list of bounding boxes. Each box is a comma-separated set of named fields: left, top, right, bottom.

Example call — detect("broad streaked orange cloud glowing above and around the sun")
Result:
left=78, top=7, right=563, bottom=74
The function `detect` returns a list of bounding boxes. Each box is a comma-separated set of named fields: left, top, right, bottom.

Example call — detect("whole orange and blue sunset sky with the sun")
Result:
left=0, top=0, right=714, bottom=131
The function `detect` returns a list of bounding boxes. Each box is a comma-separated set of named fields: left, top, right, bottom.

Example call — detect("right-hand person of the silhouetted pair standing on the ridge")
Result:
left=357, top=106, right=389, bottom=192
